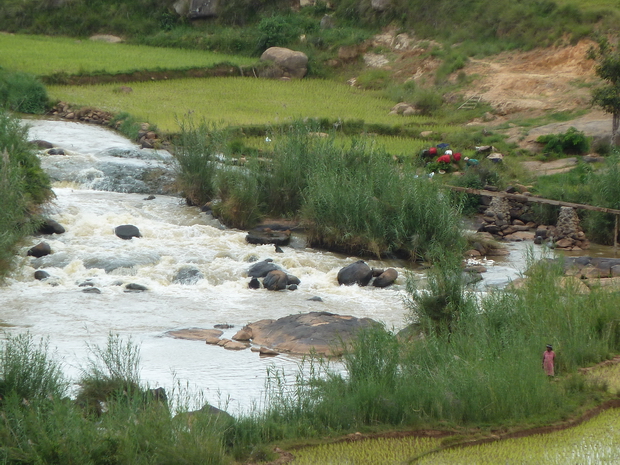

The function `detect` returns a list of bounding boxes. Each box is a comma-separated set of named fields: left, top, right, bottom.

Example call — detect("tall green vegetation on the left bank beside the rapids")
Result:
left=0, top=108, right=52, bottom=277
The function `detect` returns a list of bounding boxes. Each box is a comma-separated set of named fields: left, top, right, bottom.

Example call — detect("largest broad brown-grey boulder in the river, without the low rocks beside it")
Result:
left=247, top=312, right=379, bottom=355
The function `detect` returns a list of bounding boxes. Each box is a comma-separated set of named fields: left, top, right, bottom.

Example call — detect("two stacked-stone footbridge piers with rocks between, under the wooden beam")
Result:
left=478, top=191, right=590, bottom=251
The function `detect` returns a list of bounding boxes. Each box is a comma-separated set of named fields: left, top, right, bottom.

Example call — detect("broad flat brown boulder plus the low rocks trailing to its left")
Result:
left=166, top=312, right=378, bottom=355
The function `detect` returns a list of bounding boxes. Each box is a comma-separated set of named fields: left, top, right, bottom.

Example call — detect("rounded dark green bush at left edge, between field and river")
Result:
left=0, top=68, right=48, bottom=114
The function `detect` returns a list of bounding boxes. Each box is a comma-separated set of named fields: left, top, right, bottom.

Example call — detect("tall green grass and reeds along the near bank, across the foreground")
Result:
left=0, top=261, right=620, bottom=465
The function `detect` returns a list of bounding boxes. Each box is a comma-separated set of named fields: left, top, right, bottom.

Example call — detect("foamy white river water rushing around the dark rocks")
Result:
left=0, top=121, right=525, bottom=413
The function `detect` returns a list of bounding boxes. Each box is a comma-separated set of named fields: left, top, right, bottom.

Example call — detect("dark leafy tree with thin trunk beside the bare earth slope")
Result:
left=588, top=38, right=620, bottom=146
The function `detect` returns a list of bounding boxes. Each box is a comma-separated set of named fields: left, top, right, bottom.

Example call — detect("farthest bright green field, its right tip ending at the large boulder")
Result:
left=0, top=34, right=256, bottom=76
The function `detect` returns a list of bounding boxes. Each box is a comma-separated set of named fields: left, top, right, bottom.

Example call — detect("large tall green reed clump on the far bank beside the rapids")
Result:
left=177, top=121, right=464, bottom=259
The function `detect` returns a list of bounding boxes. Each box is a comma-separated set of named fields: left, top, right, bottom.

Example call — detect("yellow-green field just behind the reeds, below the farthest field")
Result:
left=48, top=78, right=412, bottom=132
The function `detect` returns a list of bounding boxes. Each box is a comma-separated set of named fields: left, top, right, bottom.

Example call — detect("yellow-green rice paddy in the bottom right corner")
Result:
left=292, top=409, right=620, bottom=465
